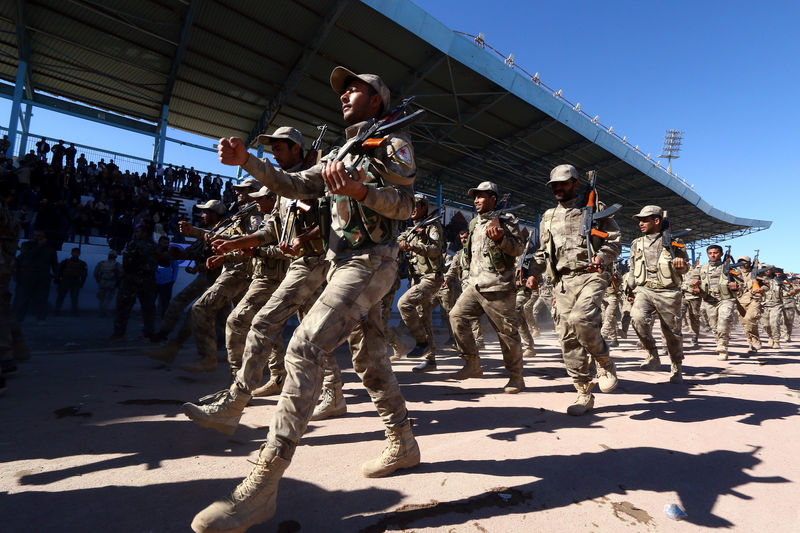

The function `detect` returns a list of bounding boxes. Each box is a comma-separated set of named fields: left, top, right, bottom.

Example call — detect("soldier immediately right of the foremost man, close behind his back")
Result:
left=397, top=194, right=444, bottom=372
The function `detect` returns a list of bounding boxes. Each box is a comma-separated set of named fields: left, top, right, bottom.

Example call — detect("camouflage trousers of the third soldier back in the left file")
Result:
left=225, top=278, right=283, bottom=373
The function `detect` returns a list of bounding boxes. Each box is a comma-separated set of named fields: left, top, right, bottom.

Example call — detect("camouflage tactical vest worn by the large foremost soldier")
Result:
left=320, top=148, right=400, bottom=249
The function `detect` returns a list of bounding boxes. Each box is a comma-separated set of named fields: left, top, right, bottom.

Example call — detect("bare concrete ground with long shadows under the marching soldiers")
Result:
left=0, top=317, right=800, bottom=533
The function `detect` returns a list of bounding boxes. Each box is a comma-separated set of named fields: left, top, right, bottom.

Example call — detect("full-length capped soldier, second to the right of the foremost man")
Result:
left=450, top=181, right=525, bottom=394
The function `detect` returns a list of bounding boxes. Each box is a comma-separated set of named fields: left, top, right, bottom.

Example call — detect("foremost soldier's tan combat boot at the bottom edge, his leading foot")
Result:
left=192, top=443, right=289, bottom=533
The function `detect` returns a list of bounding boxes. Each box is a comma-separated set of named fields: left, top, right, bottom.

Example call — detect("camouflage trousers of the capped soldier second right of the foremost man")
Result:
left=450, top=285, right=522, bottom=376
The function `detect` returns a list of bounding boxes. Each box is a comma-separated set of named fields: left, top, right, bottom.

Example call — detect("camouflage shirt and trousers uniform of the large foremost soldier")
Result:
left=237, top=114, right=416, bottom=461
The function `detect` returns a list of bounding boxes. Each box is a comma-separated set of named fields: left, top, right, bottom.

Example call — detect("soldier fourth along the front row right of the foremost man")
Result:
left=692, top=244, right=736, bottom=361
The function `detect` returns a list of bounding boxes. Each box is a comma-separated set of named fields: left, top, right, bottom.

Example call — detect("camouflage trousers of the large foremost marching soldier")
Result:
left=266, top=254, right=408, bottom=460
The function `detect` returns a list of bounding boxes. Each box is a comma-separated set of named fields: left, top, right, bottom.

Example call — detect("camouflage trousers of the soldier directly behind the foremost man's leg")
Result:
left=236, top=257, right=328, bottom=392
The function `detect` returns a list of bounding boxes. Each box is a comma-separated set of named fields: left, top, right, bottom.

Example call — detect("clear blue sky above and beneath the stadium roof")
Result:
left=0, top=0, right=800, bottom=270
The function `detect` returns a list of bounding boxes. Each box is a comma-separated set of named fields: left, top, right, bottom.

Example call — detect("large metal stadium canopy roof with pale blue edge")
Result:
left=0, top=0, right=771, bottom=242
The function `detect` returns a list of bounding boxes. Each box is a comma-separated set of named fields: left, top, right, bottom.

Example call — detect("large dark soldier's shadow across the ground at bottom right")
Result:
left=361, top=447, right=789, bottom=532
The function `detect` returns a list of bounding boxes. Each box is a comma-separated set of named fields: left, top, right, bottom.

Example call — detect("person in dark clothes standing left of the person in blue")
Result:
left=110, top=224, right=158, bottom=341
